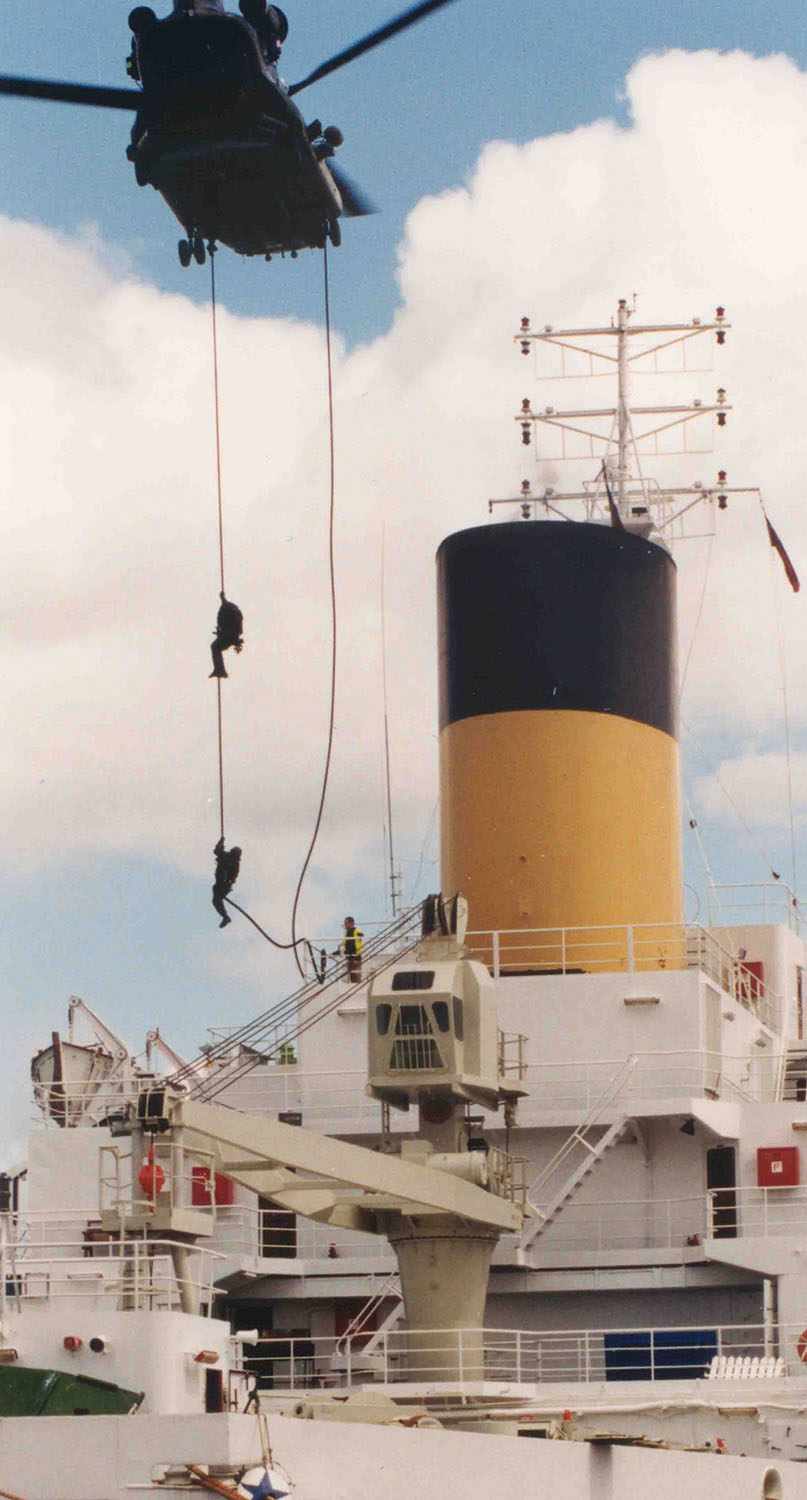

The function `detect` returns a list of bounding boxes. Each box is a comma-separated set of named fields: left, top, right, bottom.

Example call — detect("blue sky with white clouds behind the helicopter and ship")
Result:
left=0, top=0, right=807, bottom=1152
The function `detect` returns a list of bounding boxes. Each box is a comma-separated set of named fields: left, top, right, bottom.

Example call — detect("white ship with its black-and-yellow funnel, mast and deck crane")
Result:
left=0, top=303, right=807, bottom=1500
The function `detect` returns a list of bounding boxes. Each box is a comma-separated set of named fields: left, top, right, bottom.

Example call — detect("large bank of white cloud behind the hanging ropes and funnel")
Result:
left=0, top=53, right=807, bottom=960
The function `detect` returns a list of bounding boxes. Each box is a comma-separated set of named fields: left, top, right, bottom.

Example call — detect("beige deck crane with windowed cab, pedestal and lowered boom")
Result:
left=102, top=897, right=525, bottom=1379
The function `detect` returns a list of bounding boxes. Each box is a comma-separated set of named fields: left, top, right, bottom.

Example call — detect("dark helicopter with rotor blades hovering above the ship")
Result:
left=0, top=0, right=452, bottom=266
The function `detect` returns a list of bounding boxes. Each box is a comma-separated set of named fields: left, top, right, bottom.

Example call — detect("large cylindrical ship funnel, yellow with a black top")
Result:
left=437, top=521, right=681, bottom=972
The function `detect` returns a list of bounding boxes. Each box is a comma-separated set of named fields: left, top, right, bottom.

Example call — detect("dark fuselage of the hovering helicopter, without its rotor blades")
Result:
left=128, top=12, right=344, bottom=255
